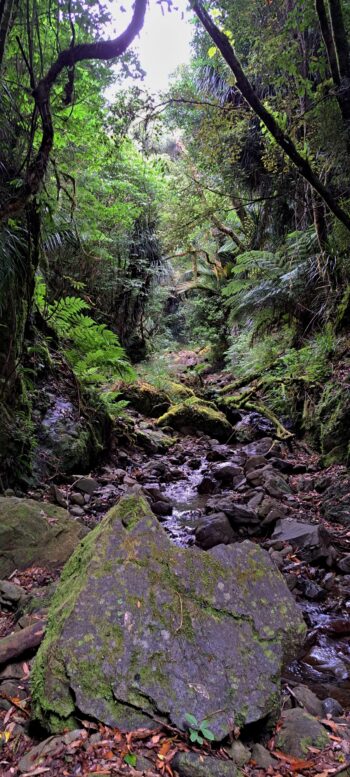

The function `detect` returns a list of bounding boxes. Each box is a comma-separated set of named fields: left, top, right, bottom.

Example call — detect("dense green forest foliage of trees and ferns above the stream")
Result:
left=0, top=0, right=350, bottom=478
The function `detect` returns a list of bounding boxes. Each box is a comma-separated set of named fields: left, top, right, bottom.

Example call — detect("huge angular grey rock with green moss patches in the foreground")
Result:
left=33, top=495, right=304, bottom=740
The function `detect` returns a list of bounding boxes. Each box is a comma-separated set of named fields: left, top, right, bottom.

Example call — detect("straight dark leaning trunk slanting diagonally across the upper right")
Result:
left=191, top=0, right=350, bottom=231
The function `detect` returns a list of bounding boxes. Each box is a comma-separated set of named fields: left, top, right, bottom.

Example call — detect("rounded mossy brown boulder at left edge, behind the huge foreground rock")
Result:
left=0, top=497, right=87, bottom=578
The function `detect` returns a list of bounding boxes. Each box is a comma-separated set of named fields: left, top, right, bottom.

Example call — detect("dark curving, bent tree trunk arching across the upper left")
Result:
left=0, top=0, right=147, bottom=221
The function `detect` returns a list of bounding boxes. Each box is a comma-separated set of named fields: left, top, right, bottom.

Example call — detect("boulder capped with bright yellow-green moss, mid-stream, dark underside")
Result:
left=157, top=397, right=233, bottom=442
